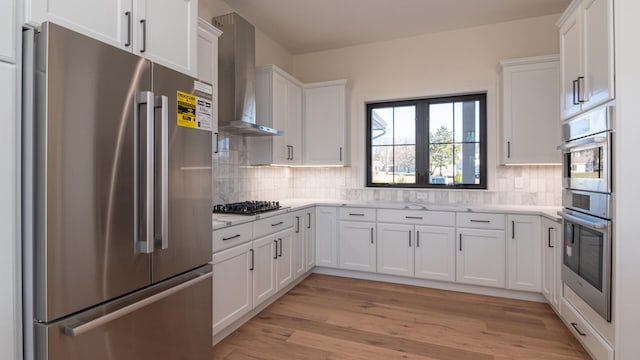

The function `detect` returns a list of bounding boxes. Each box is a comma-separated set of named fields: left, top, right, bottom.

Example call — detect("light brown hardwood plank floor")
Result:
left=214, top=274, right=590, bottom=360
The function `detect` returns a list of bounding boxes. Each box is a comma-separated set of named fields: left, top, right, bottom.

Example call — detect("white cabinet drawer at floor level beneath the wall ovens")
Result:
left=562, top=298, right=613, bottom=360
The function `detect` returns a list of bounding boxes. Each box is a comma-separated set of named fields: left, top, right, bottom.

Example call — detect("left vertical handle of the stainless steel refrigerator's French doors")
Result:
left=134, top=91, right=155, bottom=254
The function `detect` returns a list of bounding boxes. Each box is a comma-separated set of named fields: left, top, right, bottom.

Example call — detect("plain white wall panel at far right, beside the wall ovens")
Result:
left=613, top=0, right=640, bottom=360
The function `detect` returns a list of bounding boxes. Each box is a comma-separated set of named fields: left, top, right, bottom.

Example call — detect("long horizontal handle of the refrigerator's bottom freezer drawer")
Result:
left=63, top=271, right=213, bottom=337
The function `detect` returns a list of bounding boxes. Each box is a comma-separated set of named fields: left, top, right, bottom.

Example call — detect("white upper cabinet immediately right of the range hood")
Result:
left=252, top=65, right=302, bottom=165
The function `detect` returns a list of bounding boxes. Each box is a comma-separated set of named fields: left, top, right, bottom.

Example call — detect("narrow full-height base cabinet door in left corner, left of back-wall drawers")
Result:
left=316, top=206, right=338, bottom=267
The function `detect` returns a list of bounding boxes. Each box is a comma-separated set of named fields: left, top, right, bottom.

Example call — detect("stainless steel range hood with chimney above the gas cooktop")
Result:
left=213, top=13, right=284, bottom=136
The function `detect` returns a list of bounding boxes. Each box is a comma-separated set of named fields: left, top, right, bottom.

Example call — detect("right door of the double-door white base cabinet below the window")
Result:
left=415, top=226, right=456, bottom=281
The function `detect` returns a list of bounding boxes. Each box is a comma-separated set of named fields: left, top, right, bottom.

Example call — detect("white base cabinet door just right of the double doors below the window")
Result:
left=456, top=229, right=505, bottom=288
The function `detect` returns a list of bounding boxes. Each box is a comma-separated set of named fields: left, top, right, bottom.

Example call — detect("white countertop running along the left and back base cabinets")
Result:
left=212, top=199, right=561, bottom=230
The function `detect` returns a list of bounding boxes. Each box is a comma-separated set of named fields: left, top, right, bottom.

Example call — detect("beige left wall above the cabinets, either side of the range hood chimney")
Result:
left=198, top=0, right=293, bottom=72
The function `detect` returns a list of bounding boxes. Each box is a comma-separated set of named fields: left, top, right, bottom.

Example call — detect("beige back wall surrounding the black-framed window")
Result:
left=293, top=14, right=560, bottom=194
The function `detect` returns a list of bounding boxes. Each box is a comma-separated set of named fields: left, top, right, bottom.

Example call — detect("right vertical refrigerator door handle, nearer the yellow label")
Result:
left=155, top=96, right=169, bottom=249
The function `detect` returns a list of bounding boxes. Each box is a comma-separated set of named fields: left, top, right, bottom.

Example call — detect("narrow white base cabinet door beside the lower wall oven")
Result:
left=542, top=219, right=562, bottom=313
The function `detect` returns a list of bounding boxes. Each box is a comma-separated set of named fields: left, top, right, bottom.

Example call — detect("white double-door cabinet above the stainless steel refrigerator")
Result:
left=25, top=0, right=198, bottom=75
